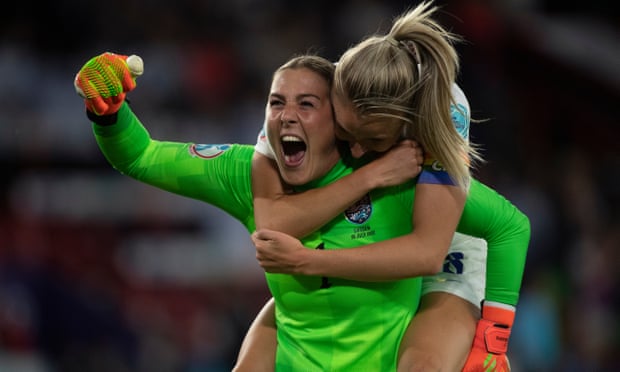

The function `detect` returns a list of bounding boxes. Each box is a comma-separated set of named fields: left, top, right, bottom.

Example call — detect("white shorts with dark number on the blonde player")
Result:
left=422, top=233, right=487, bottom=308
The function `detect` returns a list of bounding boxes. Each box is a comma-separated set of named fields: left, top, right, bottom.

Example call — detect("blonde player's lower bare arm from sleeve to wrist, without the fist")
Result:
left=299, top=185, right=466, bottom=281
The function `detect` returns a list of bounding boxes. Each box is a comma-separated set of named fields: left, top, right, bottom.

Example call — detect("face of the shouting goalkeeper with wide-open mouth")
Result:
left=265, top=68, right=340, bottom=185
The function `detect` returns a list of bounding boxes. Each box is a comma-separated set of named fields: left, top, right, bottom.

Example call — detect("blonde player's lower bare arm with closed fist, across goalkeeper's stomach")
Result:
left=252, top=184, right=466, bottom=281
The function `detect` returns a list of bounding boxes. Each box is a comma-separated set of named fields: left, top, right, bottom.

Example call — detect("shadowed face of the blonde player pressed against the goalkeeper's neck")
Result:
left=332, top=93, right=403, bottom=158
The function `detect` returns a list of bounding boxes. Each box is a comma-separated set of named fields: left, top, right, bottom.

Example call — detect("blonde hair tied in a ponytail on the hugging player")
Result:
left=334, top=2, right=482, bottom=189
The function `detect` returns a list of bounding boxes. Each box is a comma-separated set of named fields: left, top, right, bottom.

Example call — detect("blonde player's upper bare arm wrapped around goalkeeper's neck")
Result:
left=252, top=141, right=422, bottom=238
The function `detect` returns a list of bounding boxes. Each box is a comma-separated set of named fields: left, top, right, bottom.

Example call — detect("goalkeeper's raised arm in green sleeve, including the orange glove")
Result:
left=74, top=53, right=253, bottom=222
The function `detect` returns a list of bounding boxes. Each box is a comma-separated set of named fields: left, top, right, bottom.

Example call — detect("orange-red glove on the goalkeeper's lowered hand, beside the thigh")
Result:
left=463, top=301, right=515, bottom=372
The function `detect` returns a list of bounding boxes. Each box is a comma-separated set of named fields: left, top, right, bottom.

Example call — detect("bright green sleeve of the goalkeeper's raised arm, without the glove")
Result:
left=93, top=103, right=253, bottom=223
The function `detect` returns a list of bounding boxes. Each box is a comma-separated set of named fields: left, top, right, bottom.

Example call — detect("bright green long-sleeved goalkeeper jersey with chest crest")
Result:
left=94, top=103, right=529, bottom=371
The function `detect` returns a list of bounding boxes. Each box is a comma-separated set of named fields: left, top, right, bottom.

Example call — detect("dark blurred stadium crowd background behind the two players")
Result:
left=0, top=0, right=620, bottom=372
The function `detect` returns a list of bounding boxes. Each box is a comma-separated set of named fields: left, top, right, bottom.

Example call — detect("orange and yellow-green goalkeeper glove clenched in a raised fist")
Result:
left=74, top=52, right=144, bottom=116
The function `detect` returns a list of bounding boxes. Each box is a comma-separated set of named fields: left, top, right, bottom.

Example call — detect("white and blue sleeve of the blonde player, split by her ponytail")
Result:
left=418, top=84, right=471, bottom=185
